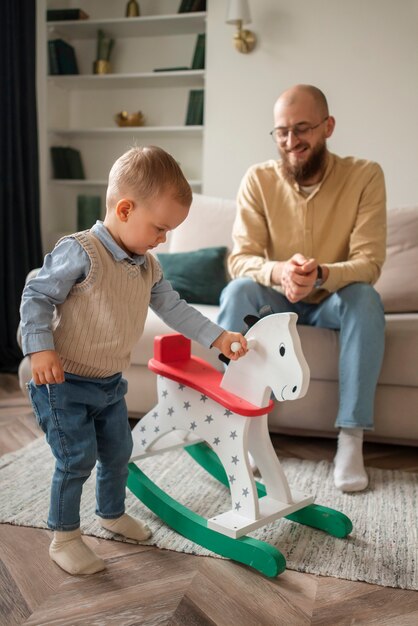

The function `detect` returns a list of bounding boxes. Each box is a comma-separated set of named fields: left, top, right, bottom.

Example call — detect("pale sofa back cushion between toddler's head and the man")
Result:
left=169, top=193, right=236, bottom=252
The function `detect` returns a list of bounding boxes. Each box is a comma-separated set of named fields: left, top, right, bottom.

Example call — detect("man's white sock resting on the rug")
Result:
left=334, top=428, right=369, bottom=491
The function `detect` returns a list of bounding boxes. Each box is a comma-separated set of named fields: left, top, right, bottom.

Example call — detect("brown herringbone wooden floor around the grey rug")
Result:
left=0, top=374, right=418, bottom=626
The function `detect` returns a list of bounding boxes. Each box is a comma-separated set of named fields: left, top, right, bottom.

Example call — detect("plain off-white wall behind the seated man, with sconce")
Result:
left=203, top=0, right=418, bottom=207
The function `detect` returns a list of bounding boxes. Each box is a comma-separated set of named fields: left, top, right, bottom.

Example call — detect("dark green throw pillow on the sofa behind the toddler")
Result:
left=157, top=246, right=227, bottom=304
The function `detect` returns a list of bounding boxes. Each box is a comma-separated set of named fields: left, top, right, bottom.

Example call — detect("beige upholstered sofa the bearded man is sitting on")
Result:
left=121, top=194, right=418, bottom=445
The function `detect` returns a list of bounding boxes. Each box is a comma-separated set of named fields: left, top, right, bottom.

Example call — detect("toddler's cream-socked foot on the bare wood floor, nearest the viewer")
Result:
left=49, top=528, right=105, bottom=576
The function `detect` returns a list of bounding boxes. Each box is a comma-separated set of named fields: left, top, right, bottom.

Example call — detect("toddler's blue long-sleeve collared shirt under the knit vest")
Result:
left=20, top=221, right=223, bottom=355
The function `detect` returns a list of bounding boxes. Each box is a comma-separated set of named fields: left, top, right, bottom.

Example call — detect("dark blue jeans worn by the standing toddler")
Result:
left=28, top=373, right=132, bottom=531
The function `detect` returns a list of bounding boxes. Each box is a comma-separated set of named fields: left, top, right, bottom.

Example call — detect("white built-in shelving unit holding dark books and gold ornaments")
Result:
left=38, top=0, right=206, bottom=249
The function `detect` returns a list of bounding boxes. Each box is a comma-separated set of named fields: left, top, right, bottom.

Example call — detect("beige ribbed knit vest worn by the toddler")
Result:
left=53, top=231, right=161, bottom=378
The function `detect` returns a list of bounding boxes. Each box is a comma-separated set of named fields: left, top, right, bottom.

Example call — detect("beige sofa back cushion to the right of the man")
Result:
left=375, top=207, right=418, bottom=313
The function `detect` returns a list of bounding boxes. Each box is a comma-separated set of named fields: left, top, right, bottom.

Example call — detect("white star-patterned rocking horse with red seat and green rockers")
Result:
left=128, top=313, right=352, bottom=577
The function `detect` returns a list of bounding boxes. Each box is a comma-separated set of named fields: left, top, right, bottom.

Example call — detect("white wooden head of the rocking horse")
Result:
left=221, top=313, right=310, bottom=406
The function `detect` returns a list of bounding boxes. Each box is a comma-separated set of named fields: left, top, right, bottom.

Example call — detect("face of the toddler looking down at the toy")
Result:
left=119, top=192, right=189, bottom=254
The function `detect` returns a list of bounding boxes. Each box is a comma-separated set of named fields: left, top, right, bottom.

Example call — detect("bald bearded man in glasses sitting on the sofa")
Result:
left=218, top=85, right=386, bottom=491
